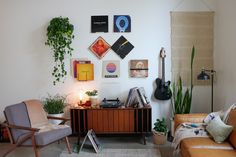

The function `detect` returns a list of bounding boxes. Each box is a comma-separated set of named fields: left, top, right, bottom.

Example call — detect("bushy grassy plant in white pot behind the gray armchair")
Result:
left=43, top=95, right=66, bottom=124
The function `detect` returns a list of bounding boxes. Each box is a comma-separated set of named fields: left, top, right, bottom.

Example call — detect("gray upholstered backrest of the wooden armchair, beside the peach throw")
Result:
left=4, top=103, right=31, bottom=142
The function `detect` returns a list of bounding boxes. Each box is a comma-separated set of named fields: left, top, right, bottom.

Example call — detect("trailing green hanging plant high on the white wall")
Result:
left=45, top=16, right=74, bottom=85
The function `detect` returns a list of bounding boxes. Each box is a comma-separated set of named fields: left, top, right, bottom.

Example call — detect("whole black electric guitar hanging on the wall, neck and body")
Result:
left=154, top=47, right=172, bottom=100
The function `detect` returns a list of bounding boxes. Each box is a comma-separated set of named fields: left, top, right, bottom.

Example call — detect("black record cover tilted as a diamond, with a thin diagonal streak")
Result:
left=111, top=36, right=134, bottom=59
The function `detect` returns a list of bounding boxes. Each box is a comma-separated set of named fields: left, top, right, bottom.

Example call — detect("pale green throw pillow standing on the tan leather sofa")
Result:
left=206, top=116, right=233, bottom=143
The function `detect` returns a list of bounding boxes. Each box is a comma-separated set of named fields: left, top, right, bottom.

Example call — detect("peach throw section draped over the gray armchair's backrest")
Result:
left=24, top=100, right=48, bottom=128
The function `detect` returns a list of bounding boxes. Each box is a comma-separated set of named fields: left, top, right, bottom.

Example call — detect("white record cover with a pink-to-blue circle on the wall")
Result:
left=102, top=60, right=120, bottom=78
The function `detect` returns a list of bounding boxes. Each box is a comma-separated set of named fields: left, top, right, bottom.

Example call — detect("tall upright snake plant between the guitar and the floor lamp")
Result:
left=171, top=46, right=195, bottom=136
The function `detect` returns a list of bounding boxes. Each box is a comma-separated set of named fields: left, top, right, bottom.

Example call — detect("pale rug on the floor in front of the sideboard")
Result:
left=60, top=148, right=161, bottom=157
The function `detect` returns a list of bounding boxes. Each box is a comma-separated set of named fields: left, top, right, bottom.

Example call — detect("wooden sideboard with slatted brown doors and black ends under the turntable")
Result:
left=70, top=107, right=152, bottom=144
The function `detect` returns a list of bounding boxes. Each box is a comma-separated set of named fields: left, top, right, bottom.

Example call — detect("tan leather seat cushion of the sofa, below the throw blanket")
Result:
left=180, top=137, right=234, bottom=157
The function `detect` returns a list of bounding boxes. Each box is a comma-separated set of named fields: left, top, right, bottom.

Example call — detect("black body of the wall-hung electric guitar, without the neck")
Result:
left=154, top=78, right=172, bottom=100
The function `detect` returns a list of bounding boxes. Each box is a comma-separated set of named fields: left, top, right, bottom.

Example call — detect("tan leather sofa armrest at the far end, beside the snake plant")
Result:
left=174, top=113, right=207, bottom=132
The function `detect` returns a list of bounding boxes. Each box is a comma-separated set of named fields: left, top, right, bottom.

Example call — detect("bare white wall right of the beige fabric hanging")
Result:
left=214, top=0, right=236, bottom=110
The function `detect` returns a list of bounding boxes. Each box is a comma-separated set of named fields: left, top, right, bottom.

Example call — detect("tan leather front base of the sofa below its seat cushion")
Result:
left=188, top=148, right=236, bottom=157
